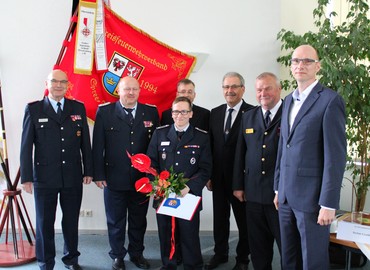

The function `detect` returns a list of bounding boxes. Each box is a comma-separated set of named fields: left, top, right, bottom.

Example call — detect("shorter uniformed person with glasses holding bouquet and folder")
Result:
left=147, top=97, right=212, bottom=270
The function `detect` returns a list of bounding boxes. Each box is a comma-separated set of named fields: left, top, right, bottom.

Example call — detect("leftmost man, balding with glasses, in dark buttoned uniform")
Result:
left=20, top=70, right=93, bottom=270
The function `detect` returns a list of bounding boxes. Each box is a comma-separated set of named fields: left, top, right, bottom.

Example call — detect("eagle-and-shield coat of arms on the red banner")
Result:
left=103, top=52, right=144, bottom=97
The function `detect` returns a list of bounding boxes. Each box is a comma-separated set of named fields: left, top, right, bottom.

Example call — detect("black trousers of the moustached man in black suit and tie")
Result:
left=212, top=182, right=250, bottom=263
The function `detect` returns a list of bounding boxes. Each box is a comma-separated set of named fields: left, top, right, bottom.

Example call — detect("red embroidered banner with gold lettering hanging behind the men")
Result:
left=55, top=6, right=196, bottom=120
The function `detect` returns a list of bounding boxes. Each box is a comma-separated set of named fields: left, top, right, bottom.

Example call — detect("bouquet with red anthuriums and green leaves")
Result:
left=127, top=152, right=189, bottom=198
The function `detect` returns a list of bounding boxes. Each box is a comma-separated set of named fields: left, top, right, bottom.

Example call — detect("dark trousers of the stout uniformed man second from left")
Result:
left=104, top=188, right=149, bottom=259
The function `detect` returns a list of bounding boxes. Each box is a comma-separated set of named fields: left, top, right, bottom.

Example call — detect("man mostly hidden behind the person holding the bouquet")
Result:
left=161, top=79, right=210, bottom=131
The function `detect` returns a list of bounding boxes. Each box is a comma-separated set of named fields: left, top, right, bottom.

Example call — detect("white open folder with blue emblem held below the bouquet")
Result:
left=157, top=193, right=202, bottom=220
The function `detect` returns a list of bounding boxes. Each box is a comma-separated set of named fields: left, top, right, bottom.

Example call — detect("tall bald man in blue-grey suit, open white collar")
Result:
left=274, top=45, right=346, bottom=270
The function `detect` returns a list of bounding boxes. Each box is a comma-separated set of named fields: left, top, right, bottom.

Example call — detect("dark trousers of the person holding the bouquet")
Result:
left=157, top=211, right=203, bottom=270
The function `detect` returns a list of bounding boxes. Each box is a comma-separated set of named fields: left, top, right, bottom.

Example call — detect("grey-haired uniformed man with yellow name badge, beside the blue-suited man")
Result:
left=233, top=72, right=282, bottom=270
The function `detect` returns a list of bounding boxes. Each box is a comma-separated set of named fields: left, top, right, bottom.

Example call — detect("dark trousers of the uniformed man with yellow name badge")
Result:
left=246, top=200, right=281, bottom=270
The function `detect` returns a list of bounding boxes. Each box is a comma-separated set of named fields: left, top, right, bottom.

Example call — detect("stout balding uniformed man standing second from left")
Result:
left=93, top=77, right=159, bottom=270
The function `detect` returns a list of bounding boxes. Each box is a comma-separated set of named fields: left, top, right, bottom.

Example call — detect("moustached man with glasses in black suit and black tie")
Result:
left=205, top=72, right=253, bottom=270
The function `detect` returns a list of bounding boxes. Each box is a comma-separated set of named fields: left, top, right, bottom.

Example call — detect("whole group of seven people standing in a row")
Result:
left=21, top=45, right=346, bottom=270
